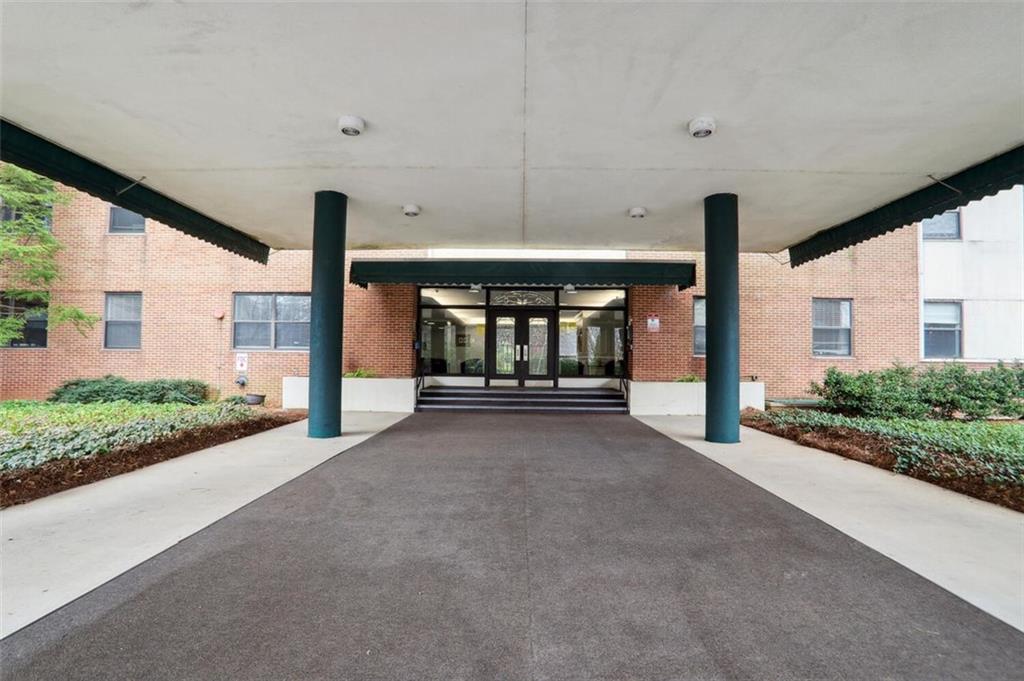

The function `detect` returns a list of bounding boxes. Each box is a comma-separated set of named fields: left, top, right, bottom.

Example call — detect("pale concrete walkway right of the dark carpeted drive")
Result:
left=640, top=416, right=1024, bottom=630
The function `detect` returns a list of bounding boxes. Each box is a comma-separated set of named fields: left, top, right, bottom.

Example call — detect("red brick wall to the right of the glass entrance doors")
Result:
left=630, top=226, right=920, bottom=397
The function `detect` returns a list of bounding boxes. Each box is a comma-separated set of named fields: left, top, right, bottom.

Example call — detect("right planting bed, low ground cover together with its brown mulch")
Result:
left=743, top=410, right=1024, bottom=512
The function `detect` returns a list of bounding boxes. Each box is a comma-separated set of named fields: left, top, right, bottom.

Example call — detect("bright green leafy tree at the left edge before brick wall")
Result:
left=0, top=163, right=99, bottom=347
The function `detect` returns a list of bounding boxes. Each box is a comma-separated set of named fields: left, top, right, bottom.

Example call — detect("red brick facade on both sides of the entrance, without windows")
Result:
left=0, top=183, right=942, bottom=405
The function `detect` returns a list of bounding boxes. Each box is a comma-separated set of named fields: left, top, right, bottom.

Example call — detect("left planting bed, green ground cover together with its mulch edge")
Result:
left=0, top=400, right=304, bottom=506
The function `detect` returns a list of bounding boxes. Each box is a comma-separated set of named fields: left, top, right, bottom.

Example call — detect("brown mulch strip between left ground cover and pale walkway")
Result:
left=0, top=411, right=306, bottom=508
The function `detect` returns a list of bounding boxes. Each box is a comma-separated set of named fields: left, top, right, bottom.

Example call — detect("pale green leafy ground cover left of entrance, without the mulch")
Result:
left=0, top=401, right=259, bottom=470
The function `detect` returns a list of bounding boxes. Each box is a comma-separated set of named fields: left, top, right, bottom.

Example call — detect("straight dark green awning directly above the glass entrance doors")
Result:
left=348, top=259, right=696, bottom=290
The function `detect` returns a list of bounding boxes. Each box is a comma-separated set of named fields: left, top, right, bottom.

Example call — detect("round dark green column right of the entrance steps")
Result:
left=705, top=194, right=739, bottom=442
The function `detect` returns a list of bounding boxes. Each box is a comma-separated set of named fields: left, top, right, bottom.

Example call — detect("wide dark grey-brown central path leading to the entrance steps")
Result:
left=4, top=414, right=1024, bottom=681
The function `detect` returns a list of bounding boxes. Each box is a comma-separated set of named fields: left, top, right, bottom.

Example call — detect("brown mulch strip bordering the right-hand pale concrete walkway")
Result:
left=742, top=415, right=1024, bottom=513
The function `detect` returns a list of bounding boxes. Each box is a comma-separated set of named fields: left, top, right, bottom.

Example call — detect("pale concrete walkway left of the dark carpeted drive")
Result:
left=0, top=413, right=407, bottom=636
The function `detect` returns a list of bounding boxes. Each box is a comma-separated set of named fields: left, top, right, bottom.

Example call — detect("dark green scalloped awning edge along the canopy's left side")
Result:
left=0, top=120, right=270, bottom=263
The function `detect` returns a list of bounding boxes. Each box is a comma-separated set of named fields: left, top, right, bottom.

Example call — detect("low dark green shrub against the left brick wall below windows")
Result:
left=50, top=375, right=209, bottom=405
